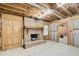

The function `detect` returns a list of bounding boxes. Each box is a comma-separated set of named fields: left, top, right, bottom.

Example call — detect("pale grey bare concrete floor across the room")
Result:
left=0, top=41, right=79, bottom=56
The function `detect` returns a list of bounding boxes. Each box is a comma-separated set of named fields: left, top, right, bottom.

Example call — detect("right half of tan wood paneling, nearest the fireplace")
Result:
left=13, top=16, right=23, bottom=47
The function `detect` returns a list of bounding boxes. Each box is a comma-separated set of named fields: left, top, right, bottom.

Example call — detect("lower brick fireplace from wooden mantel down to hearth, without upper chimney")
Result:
left=24, top=28, right=45, bottom=48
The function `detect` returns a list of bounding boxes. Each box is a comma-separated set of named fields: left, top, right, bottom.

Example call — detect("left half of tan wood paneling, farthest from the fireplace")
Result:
left=2, top=14, right=12, bottom=49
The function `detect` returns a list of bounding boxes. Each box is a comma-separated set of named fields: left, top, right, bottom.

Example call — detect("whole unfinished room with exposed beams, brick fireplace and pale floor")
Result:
left=0, top=3, right=79, bottom=56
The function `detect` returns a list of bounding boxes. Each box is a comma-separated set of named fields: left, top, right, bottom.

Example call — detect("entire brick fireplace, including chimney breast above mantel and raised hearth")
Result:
left=24, top=18, right=45, bottom=48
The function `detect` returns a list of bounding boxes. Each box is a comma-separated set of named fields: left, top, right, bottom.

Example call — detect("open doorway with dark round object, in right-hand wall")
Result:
left=57, top=23, right=68, bottom=44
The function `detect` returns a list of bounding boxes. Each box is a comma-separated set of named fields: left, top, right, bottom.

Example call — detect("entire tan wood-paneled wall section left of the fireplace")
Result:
left=2, top=14, right=23, bottom=50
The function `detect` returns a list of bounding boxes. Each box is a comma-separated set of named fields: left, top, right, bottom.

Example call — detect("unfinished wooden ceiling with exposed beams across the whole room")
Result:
left=0, top=3, right=79, bottom=21
